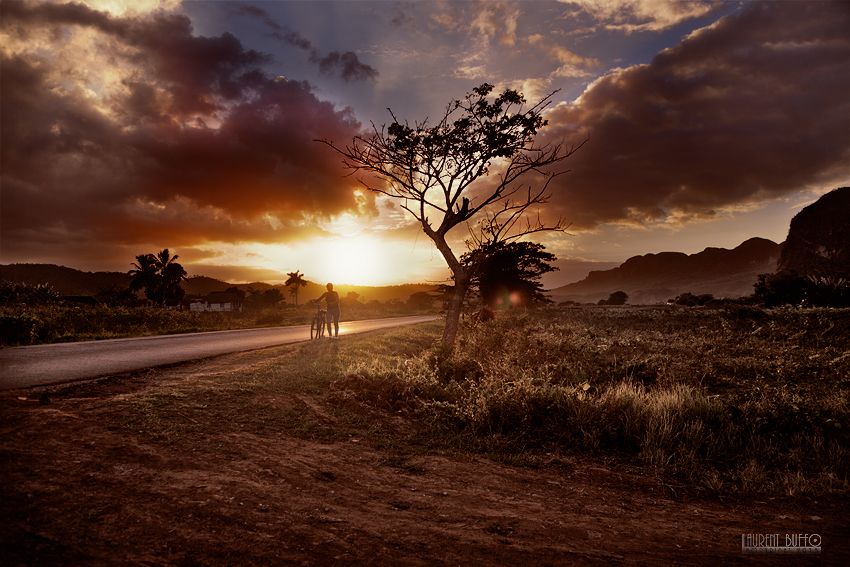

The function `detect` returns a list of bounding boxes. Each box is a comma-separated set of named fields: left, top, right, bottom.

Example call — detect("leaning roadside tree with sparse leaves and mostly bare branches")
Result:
left=317, top=83, right=580, bottom=347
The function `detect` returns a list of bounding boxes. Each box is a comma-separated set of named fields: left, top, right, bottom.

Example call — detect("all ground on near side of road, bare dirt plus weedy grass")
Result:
left=0, top=306, right=850, bottom=566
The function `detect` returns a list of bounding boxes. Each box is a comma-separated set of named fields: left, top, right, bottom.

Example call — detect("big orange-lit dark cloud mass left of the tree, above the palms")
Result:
left=0, top=2, right=371, bottom=261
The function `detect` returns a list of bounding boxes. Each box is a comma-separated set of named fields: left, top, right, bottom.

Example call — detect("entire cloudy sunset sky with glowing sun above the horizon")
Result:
left=0, top=0, right=850, bottom=288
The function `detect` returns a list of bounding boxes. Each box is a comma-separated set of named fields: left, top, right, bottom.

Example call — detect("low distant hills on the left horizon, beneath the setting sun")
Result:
left=0, top=264, right=437, bottom=304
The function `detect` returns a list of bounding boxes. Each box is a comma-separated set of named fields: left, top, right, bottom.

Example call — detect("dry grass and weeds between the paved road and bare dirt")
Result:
left=101, top=308, right=850, bottom=495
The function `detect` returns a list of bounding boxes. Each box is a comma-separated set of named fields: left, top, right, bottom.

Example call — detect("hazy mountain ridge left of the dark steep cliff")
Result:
left=548, top=238, right=782, bottom=304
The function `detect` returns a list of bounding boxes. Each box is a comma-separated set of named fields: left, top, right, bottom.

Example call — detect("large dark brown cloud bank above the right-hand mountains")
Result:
left=545, top=2, right=850, bottom=228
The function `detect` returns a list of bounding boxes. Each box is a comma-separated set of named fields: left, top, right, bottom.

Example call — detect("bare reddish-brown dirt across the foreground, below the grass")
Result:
left=0, top=356, right=850, bottom=566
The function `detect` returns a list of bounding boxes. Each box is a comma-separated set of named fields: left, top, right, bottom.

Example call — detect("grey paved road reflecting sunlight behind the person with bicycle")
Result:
left=0, top=315, right=437, bottom=390
